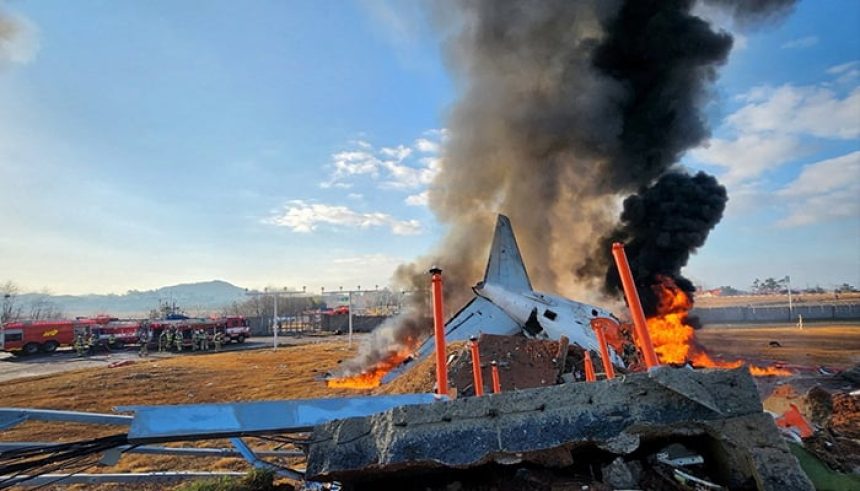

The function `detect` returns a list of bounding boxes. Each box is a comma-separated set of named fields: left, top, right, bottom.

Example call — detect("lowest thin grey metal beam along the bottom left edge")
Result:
left=0, top=471, right=245, bottom=486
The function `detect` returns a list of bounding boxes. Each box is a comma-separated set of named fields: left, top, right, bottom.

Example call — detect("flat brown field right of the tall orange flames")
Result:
left=696, top=322, right=860, bottom=369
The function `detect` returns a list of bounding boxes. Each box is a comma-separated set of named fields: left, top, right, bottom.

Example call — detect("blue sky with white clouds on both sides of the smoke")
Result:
left=0, top=0, right=860, bottom=294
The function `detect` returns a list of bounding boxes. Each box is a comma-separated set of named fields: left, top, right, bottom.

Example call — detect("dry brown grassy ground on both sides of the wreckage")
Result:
left=0, top=323, right=860, bottom=489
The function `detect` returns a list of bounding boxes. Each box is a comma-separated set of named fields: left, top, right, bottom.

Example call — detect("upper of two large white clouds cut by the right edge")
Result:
left=727, top=85, right=860, bottom=139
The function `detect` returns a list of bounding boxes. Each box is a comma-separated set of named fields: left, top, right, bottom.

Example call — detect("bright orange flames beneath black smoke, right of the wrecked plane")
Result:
left=647, top=277, right=791, bottom=377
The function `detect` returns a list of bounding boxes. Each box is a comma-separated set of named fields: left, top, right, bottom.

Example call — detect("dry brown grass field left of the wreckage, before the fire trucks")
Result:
left=0, top=340, right=367, bottom=489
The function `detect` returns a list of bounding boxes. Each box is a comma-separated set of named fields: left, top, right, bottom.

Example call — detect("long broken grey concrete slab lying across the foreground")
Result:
left=307, top=367, right=812, bottom=490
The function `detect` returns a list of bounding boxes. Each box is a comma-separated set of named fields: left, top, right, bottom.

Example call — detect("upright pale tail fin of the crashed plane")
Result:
left=484, top=215, right=532, bottom=292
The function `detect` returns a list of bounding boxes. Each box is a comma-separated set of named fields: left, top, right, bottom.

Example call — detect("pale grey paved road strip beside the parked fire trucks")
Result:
left=0, top=334, right=364, bottom=386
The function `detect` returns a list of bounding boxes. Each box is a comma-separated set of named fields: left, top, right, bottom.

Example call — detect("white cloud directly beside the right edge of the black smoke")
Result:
left=690, top=133, right=805, bottom=185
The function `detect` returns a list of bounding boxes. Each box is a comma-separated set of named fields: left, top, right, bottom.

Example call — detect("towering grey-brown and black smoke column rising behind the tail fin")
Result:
left=336, top=0, right=793, bottom=376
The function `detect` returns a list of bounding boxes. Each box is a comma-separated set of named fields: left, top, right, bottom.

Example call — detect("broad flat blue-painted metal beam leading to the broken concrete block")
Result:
left=116, top=394, right=438, bottom=443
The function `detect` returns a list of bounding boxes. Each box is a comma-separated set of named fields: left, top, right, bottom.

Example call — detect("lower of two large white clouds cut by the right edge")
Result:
left=776, top=151, right=860, bottom=227
